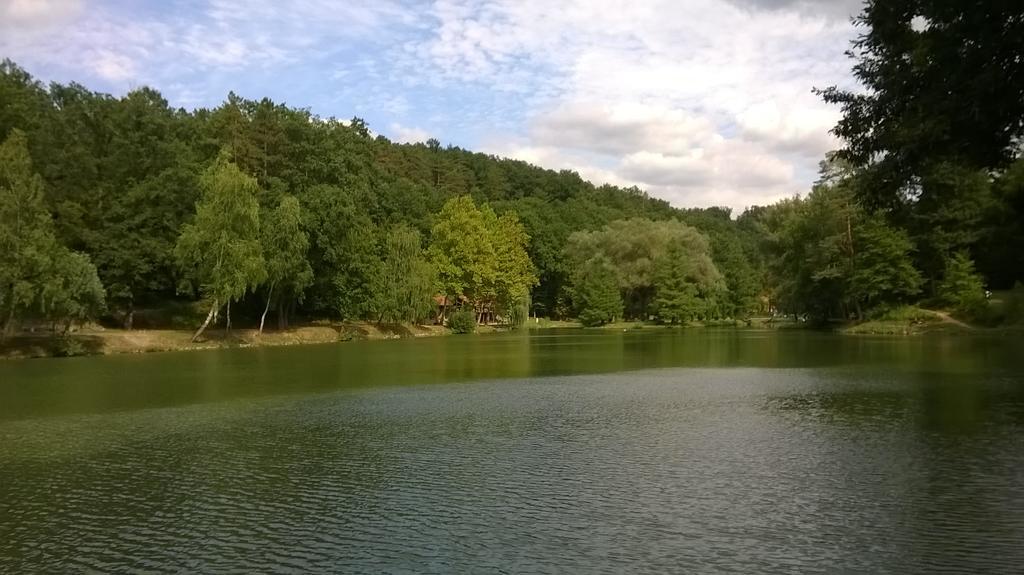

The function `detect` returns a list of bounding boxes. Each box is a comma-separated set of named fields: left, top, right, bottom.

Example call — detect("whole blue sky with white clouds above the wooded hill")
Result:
left=0, top=0, right=859, bottom=210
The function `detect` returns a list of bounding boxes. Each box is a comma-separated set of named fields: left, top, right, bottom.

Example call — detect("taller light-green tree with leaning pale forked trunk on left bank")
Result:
left=174, top=152, right=266, bottom=342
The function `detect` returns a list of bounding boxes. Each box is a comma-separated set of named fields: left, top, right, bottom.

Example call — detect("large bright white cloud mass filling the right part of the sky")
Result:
left=407, top=0, right=856, bottom=209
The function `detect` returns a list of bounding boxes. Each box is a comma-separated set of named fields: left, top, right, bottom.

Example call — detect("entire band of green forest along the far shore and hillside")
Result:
left=0, top=2, right=1024, bottom=337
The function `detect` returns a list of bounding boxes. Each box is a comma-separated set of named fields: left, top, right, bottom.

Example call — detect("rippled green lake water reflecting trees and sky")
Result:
left=0, top=329, right=1024, bottom=574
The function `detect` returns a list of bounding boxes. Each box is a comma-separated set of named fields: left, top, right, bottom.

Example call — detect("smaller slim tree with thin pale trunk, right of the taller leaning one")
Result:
left=259, top=195, right=313, bottom=334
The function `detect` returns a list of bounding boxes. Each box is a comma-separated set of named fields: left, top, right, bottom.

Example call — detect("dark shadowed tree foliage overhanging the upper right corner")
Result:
left=821, top=0, right=1024, bottom=206
